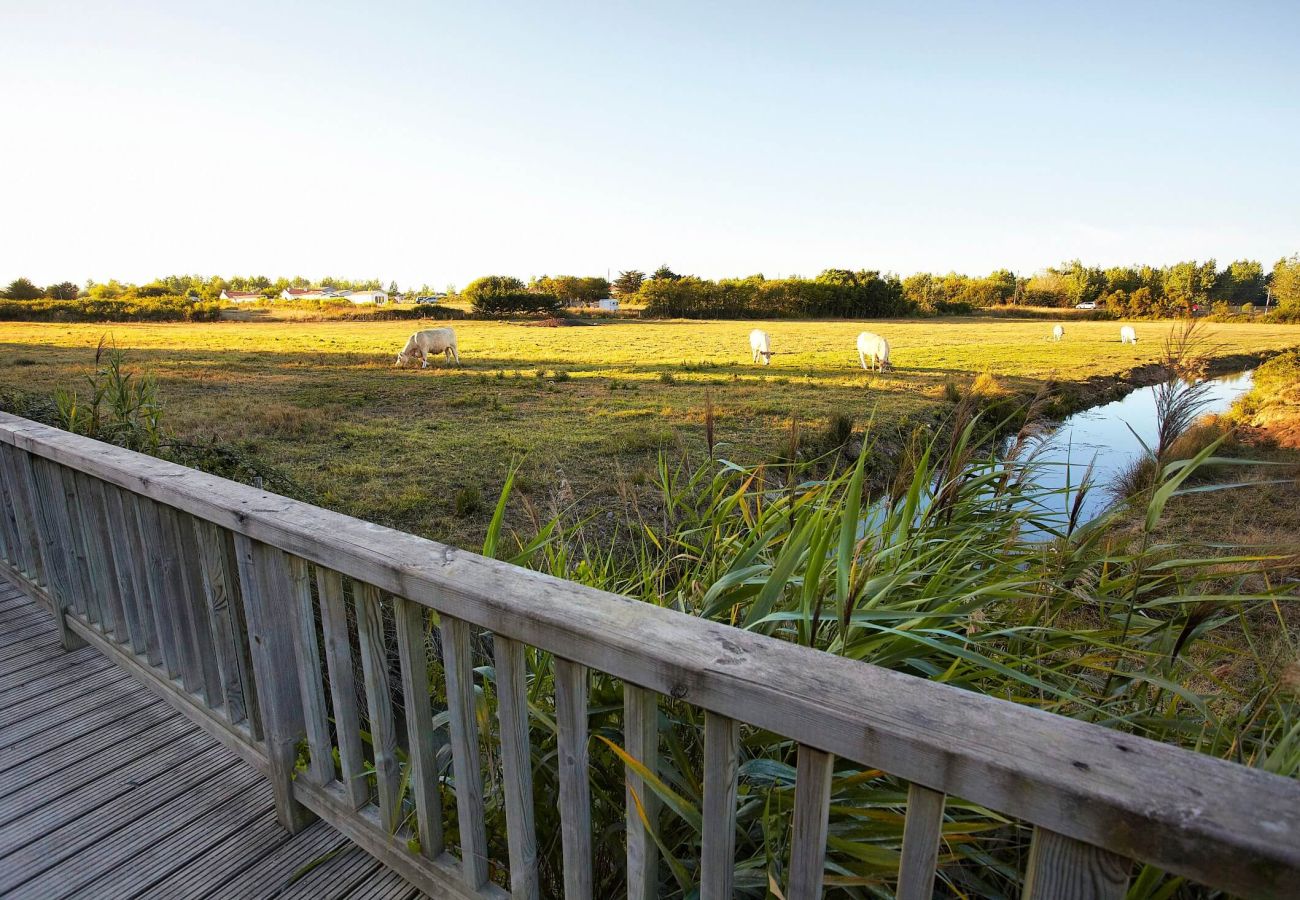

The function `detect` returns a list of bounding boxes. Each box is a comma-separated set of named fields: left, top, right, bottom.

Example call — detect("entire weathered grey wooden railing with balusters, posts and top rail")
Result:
left=0, top=415, right=1300, bottom=900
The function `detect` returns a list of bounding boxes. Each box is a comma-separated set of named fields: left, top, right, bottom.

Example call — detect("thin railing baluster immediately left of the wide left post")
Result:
left=191, top=519, right=256, bottom=734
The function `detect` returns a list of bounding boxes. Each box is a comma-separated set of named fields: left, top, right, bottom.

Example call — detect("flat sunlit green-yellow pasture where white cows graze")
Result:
left=0, top=319, right=1300, bottom=544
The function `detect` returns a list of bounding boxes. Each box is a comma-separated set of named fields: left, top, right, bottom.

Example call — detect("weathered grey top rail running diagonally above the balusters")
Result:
left=0, top=414, right=1300, bottom=895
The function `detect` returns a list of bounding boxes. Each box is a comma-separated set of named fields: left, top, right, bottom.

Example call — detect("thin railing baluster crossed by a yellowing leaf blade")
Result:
left=623, top=684, right=659, bottom=900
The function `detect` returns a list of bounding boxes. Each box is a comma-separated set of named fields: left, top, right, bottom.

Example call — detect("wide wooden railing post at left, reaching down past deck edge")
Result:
left=235, top=535, right=312, bottom=834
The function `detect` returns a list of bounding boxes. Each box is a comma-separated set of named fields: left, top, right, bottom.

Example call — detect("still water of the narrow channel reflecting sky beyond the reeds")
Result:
left=1034, top=372, right=1255, bottom=524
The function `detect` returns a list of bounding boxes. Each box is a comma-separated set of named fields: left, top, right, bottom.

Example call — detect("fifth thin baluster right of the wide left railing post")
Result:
left=442, top=615, right=488, bottom=890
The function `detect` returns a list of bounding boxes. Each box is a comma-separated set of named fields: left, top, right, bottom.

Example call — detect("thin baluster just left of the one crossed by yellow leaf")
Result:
left=555, top=657, right=592, bottom=900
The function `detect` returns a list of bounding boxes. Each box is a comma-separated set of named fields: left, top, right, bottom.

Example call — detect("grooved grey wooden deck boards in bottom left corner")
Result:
left=0, top=577, right=420, bottom=900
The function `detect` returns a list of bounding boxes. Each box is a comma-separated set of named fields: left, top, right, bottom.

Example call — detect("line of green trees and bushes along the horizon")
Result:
left=0, top=255, right=1300, bottom=319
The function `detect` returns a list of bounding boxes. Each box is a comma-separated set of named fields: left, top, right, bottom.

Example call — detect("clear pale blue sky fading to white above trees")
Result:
left=0, top=0, right=1300, bottom=286
